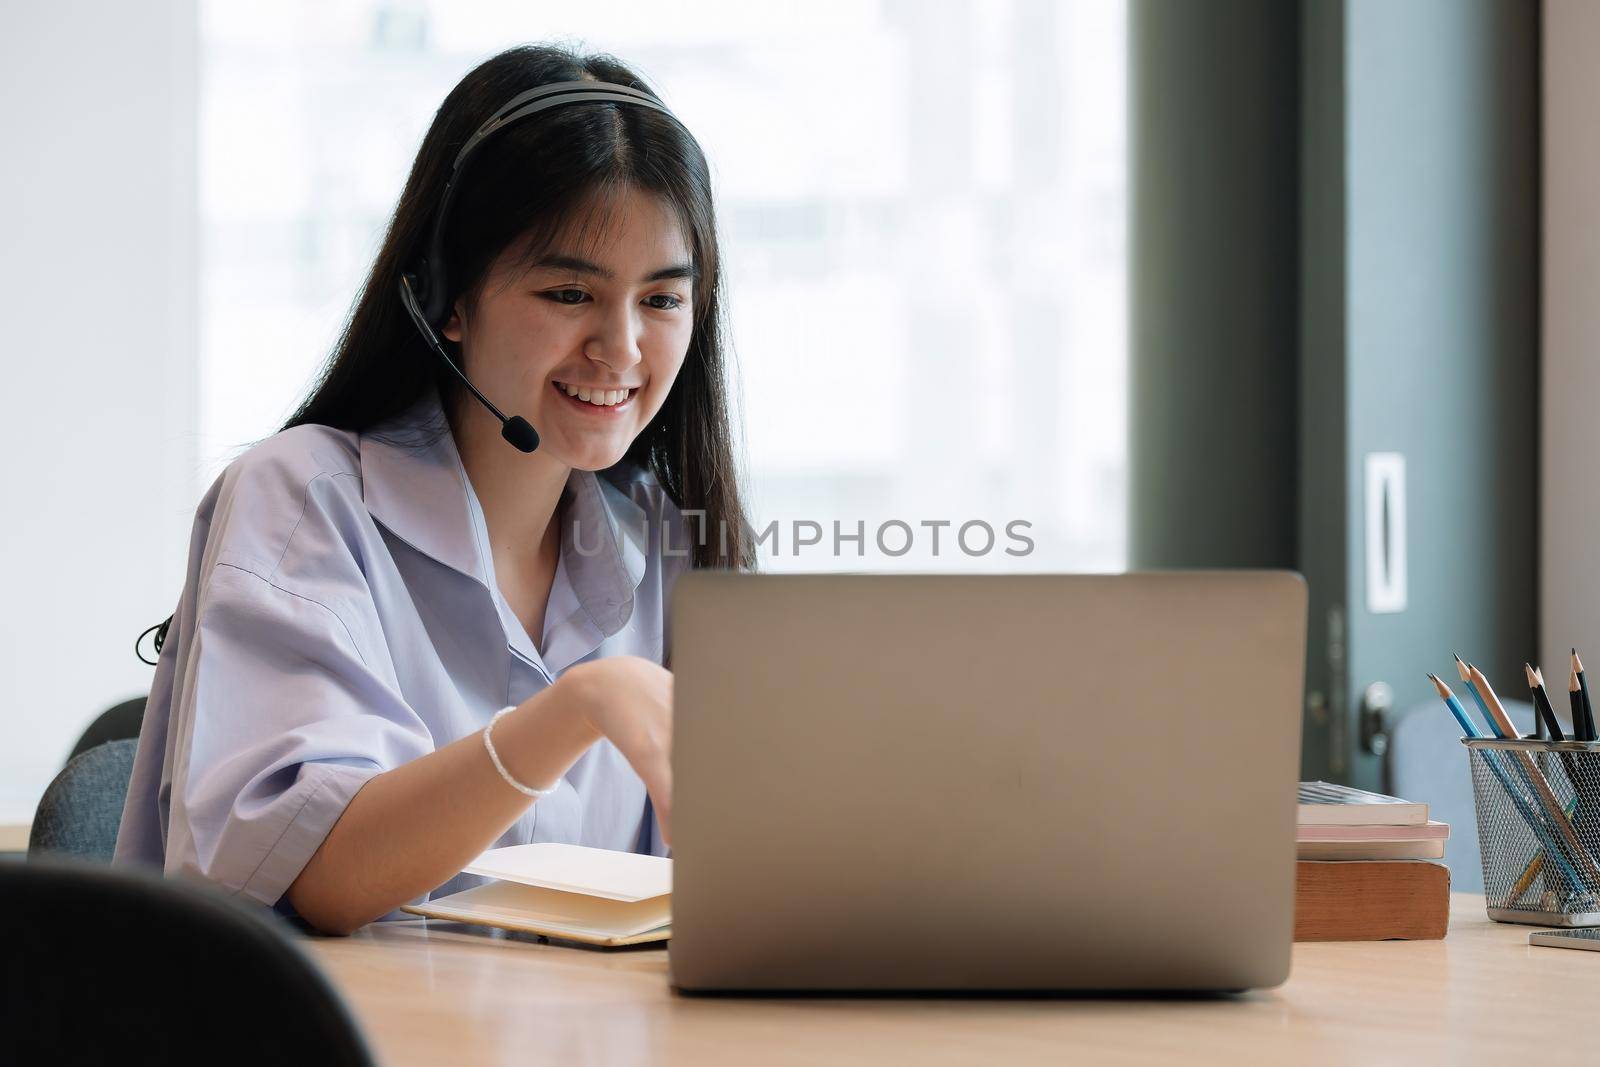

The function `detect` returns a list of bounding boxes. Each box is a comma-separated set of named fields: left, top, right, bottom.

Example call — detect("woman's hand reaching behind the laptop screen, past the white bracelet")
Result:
left=555, top=656, right=672, bottom=845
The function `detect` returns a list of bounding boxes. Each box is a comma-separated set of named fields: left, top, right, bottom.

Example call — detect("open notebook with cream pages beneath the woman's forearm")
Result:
left=402, top=841, right=672, bottom=945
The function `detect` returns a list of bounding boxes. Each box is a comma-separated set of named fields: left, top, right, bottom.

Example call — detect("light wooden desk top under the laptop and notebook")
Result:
left=310, top=894, right=1600, bottom=1067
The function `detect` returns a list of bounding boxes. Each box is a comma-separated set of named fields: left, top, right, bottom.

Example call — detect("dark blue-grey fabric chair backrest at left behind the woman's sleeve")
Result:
left=27, top=739, right=139, bottom=862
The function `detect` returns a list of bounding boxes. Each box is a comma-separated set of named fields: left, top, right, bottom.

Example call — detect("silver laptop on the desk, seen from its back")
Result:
left=670, top=571, right=1306, bottom=990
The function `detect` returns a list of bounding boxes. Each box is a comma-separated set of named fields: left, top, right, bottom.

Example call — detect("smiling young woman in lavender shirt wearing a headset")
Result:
left=117, top=48, right=752, bottom=933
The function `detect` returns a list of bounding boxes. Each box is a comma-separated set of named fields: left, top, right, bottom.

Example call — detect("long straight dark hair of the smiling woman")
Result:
left=285, top=45, right=755, bottom=568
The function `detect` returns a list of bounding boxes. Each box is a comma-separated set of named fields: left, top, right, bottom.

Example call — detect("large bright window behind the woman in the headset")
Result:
left=202, top=0, right=1126, bottom=571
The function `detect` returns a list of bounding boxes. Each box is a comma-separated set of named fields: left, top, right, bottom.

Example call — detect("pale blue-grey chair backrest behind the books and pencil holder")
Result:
left=1384, top=696, right=1533, bottom=893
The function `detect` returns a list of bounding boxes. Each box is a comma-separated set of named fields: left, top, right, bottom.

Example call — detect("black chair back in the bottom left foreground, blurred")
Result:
left=0, top=861, right=373, bottom=1067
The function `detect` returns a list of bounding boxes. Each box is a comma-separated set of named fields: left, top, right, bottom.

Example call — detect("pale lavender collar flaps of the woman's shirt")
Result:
left=360, top=390, right=650, bottom=637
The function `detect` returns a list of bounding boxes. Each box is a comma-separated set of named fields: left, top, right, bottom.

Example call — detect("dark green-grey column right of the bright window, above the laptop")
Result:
left=1128, top=0, right=1299, bottom=568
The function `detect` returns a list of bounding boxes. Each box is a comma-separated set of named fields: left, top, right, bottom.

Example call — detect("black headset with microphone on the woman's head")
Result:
left=400, top=82, right=683, bottom=453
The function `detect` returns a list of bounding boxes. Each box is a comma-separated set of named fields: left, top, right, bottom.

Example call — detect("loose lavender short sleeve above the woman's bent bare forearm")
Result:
left=165, top=563, right=434, bottom=905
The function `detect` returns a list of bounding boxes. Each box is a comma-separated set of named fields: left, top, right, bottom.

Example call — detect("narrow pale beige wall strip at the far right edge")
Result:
left=1539, top=0, right=1600, bottom=697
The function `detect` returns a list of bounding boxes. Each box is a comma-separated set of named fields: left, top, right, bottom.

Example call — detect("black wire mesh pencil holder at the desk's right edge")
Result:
left=1462, top=737, right=1600, bottom=926
